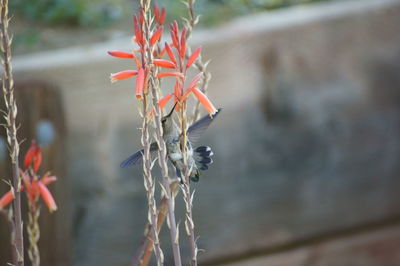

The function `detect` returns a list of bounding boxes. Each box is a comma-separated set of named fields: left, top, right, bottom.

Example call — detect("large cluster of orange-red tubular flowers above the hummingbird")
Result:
left=108, top=6, right=217, bottom=115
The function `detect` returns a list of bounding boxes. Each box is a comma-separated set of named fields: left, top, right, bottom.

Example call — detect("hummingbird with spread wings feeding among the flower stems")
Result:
left=120, top=104, right=221, bottom=182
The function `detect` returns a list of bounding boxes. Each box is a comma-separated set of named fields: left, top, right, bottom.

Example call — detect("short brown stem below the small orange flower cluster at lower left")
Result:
left=26, top=202, right=40, bottom=266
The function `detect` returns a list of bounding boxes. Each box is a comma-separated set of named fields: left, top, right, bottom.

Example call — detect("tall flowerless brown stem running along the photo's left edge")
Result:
left=0, top=0, right=24, bottom=266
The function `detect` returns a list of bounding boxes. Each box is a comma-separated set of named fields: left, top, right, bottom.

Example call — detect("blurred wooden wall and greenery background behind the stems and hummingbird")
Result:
left=0, top=0, right=400, bottom=266
